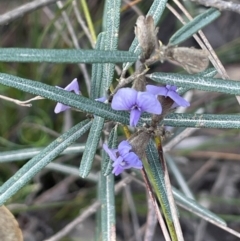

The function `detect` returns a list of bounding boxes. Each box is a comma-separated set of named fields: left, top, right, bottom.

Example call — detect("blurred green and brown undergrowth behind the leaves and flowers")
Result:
left=0, top=0, right=240, bottom=241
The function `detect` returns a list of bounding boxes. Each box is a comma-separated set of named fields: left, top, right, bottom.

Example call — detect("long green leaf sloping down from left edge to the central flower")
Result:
left=0, top=73, right=129, bottom=125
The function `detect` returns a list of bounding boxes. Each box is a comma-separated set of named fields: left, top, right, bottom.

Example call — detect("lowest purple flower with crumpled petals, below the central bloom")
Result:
left=103, top=141, right=143, bottom=176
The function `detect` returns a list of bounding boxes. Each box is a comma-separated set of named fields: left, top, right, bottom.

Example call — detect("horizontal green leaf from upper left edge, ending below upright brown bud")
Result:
left=0, top=48, right=138, bottom=63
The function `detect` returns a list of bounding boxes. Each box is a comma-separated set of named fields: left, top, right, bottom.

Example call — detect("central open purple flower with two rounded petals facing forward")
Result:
left=112, top=88, right=162, bottom=126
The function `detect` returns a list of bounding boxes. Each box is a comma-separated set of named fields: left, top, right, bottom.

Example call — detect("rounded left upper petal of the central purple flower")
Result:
left=111, top=88, right=137, bottom=110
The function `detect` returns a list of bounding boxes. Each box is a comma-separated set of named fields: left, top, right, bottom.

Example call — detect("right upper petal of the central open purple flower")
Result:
left=137, top=92, right=162, bottom=115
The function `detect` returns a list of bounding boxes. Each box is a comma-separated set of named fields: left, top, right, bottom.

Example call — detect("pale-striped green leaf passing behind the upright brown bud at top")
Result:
left=123, top=0, right=167, bottom=70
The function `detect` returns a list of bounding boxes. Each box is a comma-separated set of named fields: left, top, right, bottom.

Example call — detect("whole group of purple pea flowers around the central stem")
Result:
left=54, top=79, right=190, bottom=176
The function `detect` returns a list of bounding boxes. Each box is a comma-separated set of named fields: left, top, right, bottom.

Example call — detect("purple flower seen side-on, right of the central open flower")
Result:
left=146, top=85, right=190, bottom=107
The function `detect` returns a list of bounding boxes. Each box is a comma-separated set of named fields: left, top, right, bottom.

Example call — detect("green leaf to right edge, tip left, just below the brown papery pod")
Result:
left=147, top=73, right=240, bottom=95
